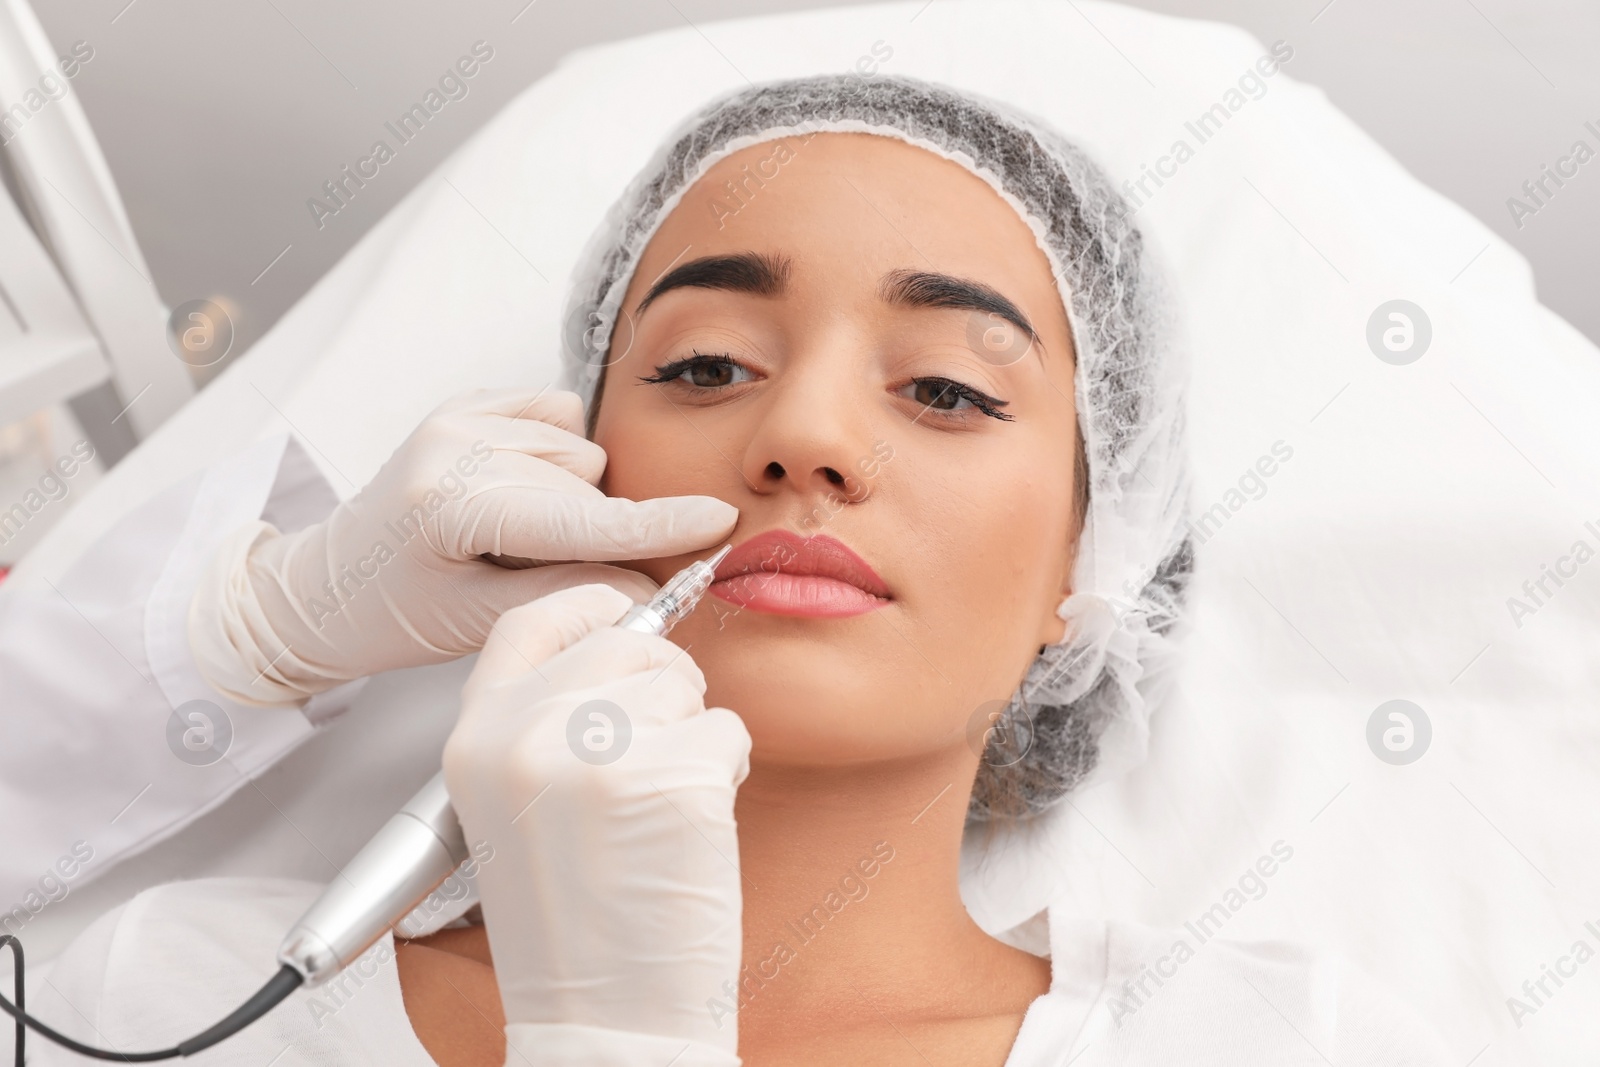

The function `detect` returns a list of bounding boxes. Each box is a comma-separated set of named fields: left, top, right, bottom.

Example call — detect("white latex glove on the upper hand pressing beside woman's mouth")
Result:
left=189, top=389, right=738, bottom=704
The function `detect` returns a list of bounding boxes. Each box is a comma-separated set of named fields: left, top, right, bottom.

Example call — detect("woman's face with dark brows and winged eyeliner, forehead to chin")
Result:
left=594, top=133, right=1078, bottom=777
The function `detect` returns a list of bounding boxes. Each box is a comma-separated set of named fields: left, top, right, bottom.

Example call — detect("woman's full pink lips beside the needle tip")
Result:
left=710, top=530, right=890, bottom=619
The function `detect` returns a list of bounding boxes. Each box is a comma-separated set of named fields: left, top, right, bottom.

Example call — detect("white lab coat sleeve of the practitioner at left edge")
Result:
left=0, top=435, right=398, bottom=960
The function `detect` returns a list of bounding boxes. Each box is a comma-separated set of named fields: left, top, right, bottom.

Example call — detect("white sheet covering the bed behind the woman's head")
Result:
left=10, top=0, right=1600, bottom=1067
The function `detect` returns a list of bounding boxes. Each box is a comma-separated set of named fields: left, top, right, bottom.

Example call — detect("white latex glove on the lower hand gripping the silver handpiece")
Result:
left=445, top=585, right=750, bottom=1067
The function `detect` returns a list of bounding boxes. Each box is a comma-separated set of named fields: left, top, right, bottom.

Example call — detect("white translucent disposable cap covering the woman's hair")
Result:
left=562, top=75, right=1194, bottom=819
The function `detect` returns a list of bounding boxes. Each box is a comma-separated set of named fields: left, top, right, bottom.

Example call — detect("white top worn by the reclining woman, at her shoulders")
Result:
left=29, top=878, right=1462, bottom=1067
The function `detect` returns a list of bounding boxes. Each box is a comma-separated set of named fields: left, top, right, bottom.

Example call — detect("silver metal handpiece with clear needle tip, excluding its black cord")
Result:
left=278, top=545, right=733, bottom=989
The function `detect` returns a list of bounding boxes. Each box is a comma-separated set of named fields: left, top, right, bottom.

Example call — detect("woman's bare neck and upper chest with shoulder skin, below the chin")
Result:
left=397, top=751, right=1050, bottom=1067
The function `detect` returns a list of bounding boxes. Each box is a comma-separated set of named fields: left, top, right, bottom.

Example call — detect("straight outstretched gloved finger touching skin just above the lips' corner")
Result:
left=462, top=490, right=739, bottom=561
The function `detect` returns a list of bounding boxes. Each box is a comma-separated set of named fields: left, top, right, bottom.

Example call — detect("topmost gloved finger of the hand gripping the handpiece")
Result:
left=461, top=585, right=634, bottom=703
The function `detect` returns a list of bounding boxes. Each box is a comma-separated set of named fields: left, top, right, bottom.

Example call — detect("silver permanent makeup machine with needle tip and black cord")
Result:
left=0, top=545, right=733, bottom=1064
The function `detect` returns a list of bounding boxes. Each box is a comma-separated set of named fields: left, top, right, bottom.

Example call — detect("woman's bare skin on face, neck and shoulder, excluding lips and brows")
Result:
left=398, top=133, right=1078, bottom=1067
